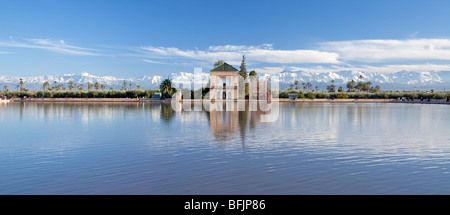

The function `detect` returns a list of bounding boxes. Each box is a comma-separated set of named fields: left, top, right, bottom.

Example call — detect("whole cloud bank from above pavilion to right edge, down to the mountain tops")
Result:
left=140, top=38, right=450, bottom=74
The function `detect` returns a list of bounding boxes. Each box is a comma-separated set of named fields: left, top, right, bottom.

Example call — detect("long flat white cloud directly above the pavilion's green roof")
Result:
left=141, top=44, right=341, bottom=64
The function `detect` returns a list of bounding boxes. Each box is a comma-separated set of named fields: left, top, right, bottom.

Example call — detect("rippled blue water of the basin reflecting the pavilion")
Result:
left=0, top=103, right=450, bottom=194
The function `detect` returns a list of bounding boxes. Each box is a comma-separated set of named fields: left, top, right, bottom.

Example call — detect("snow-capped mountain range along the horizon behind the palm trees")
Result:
left=0, top=70, right=450, bottom=91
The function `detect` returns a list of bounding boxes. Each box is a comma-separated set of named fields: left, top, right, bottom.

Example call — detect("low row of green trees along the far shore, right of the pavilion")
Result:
left=274, top=90, right=450, bottom=99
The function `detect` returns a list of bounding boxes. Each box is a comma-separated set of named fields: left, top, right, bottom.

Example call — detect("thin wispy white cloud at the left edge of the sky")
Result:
left=0, top=37, right=100, bottom=56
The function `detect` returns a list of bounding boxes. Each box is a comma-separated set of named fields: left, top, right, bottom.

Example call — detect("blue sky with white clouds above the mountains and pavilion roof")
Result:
left=0, top=0, right=450, bottom=77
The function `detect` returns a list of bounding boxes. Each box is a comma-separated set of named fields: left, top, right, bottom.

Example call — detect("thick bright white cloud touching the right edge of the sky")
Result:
left=320, top=39, right=450, bottom=62
